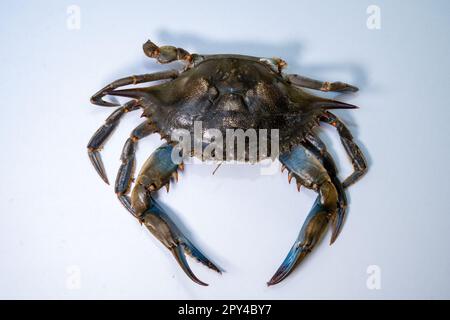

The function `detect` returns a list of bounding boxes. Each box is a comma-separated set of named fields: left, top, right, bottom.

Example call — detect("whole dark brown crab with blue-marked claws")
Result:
left=87, top=40, right=367, bottom=286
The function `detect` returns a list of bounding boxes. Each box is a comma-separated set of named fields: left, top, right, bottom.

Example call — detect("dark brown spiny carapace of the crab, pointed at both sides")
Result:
left=110, top=55, right=355, bottom=160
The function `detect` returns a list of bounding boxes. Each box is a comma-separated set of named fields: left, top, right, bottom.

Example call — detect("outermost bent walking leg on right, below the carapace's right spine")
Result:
left=320, top=111, right=367, bottom=188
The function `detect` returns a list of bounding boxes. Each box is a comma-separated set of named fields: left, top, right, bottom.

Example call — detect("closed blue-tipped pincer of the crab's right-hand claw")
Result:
left=267, top=196, right=329, bottom=286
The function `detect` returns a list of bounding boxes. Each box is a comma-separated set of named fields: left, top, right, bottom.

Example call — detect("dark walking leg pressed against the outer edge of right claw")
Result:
left=303, top=134, right=347, bottom=244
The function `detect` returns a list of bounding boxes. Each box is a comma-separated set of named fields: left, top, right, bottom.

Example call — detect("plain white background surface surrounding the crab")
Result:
left=0, top=0, right=450, bottom=299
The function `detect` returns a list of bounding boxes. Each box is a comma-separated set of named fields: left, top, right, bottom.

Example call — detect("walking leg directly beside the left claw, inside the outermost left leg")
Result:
left=115, top=121, right=156, bottom=215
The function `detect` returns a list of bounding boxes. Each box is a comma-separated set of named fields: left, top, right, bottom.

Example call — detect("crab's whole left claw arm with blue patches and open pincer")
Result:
left=131, top=144, right=221, bottom=286
